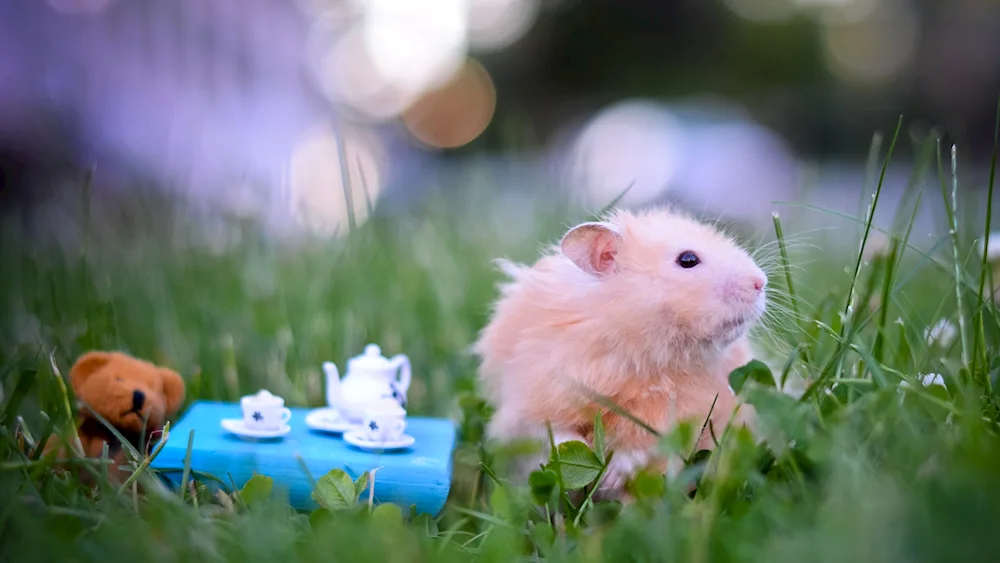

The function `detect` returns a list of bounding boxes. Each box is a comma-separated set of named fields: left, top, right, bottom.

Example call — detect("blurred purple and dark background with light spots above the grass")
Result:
left=0, top=0, right=1000, bottom=238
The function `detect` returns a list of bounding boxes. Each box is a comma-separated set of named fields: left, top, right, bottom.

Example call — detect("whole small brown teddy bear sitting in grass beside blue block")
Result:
left=45, top=351, right=185, bottom=481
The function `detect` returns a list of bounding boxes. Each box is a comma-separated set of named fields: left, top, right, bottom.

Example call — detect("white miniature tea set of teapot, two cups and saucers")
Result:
left=222, top=344, right=415, bottom=450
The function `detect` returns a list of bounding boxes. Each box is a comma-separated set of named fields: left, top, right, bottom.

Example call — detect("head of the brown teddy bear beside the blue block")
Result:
left=69, top=352, right=184, bottom=433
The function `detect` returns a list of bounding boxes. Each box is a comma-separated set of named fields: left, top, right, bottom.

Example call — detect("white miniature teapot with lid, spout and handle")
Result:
left=323, top=344, right=410, bottom=422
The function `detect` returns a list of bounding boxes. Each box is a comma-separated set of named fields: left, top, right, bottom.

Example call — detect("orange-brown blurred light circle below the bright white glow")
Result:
left=403, top=59, right=496, bottom=148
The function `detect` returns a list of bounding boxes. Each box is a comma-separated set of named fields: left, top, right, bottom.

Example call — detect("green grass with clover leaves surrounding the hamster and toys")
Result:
left=0, top=119, right=1000, bottom=563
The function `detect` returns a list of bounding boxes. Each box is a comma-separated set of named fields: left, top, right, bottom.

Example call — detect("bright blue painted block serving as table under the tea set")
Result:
left=151, top=401, right=456, bottom=515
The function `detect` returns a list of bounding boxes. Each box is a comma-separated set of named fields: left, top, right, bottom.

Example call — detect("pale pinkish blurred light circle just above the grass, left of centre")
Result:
left=288, top=123, right=386, bottom=235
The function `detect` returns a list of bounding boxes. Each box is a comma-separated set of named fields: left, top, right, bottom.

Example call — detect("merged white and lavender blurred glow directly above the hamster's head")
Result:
left=556, top=99, right=799, bottom=220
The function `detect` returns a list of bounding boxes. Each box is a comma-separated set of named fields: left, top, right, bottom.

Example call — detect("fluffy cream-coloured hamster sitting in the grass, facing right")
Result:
left=472, top=207, right=768, bottom=499
